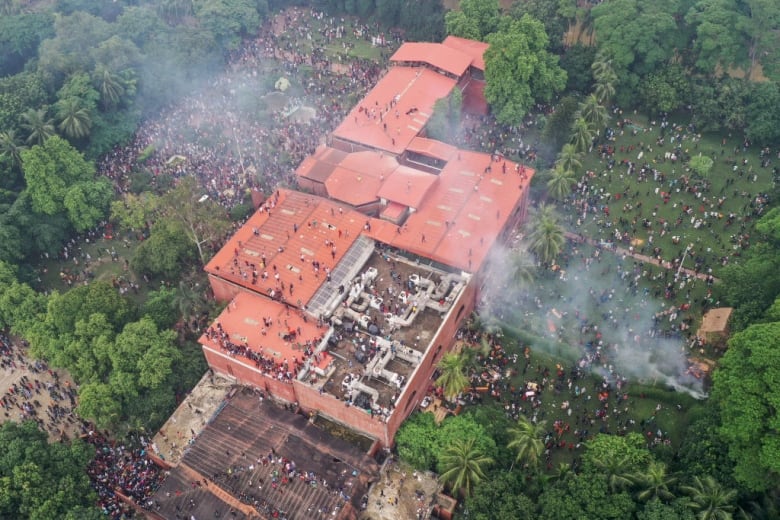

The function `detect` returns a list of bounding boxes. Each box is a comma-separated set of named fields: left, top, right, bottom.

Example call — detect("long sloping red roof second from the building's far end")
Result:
left=333, top=67, right=456, bottom=155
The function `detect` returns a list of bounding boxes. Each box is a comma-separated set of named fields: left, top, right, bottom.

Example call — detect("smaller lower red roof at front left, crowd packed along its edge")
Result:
left=199, top=292, right=330, bottom=370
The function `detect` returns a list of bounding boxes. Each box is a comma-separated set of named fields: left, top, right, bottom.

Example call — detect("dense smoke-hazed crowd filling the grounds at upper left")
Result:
left=99, top=7, right=382, bottom=213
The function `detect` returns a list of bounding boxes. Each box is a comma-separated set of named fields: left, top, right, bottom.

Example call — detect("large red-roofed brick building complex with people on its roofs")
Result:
left=200, top=38, right=534, bottom=450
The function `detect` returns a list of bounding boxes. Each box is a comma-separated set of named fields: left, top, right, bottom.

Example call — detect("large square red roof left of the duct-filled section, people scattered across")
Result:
left=205, top=190, right=367, bottom=306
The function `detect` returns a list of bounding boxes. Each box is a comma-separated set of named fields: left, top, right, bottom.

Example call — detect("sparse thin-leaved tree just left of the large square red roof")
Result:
left=157, top=177, right=230, bottom=264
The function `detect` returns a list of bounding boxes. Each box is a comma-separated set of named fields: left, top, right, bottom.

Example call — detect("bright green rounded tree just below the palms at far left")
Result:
left=22, top=136, right=95, bottom=215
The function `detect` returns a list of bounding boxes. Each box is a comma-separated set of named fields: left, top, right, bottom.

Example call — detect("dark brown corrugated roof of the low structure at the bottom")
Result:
left=152, top=388, right=379, bottom=520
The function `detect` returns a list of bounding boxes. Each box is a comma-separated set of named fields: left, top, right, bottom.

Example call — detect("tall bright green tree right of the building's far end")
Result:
left=485, top=15, right=566, bottom=125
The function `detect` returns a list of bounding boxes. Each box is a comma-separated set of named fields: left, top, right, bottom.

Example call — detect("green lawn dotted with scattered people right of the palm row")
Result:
left=567, top=114, right=773, bottom=276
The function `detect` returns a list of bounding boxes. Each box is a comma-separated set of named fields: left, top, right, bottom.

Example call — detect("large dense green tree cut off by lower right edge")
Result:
left=713, top=322, right=780, bottom=491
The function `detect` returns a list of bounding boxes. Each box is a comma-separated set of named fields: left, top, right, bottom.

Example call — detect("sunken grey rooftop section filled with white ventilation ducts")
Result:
left=300, top=250, right=468, bottom=416
